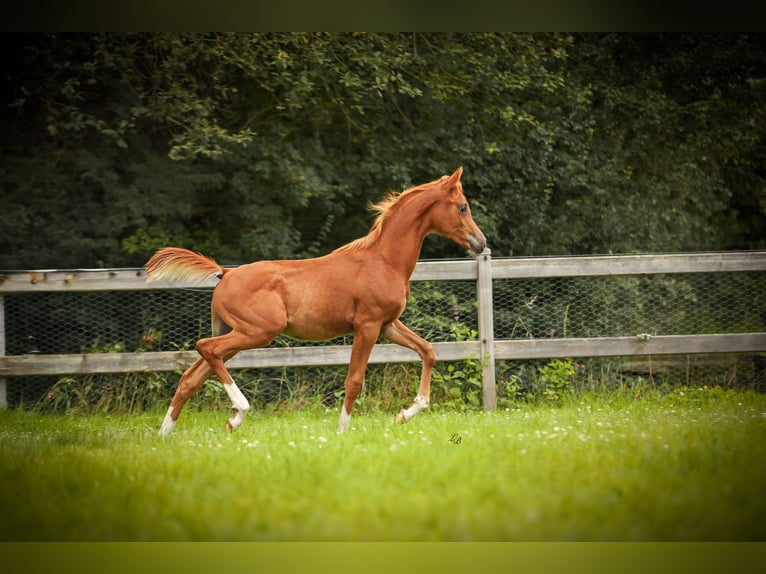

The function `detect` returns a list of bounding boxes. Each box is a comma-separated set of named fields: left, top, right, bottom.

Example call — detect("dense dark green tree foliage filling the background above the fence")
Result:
left=0, top=33, right=766, bottom=268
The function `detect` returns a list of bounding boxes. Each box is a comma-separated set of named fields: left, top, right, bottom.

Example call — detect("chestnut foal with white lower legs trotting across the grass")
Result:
left=146, top=168, right=486, bottom=436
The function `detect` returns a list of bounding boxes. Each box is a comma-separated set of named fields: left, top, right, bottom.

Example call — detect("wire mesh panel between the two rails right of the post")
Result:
left=493, top=272, right=766, bottom=339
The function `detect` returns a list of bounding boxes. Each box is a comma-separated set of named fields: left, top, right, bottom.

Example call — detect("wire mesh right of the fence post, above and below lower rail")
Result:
left=493, top=272, right=766, bottom=404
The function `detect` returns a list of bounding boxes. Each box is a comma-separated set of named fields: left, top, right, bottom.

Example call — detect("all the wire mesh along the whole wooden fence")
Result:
left=4, top=258, right=766, bottom=409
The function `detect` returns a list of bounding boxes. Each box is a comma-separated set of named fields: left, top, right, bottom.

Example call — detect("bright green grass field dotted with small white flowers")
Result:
left=0, top=389, right=766, bottom=541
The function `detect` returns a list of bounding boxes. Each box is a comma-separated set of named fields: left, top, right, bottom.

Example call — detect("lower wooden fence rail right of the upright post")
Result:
left=495, top=333, right=766, bottom=360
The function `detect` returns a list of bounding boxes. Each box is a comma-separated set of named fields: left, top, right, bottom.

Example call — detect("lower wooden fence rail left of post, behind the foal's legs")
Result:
left=0, top=341, right=480, bottom=377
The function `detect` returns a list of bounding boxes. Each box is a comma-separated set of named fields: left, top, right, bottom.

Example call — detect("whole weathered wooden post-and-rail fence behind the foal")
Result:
left=0, top=251, right=766, bottom=409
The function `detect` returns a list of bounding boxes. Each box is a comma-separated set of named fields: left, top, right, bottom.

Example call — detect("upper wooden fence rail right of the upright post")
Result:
left=492, top=251, right=766, bottom=279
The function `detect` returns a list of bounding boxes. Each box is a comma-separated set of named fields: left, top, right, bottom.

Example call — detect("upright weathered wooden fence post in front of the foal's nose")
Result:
left=476, top=248, right=497, bottom=411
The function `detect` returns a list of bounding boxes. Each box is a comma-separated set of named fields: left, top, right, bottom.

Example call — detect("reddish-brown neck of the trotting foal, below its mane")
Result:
left=371, top=197, right=431, bottom=279
